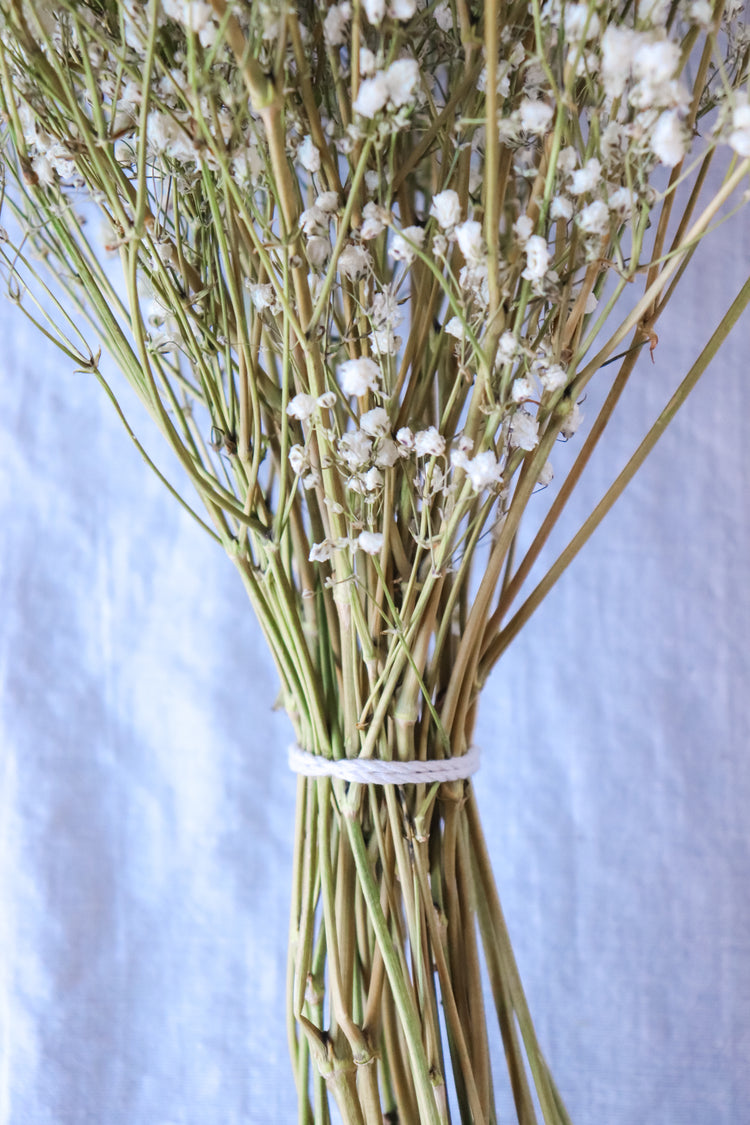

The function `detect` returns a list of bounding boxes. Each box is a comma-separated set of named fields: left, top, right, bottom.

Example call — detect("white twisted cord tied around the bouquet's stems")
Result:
left=289, top=745, right=479, bottom=785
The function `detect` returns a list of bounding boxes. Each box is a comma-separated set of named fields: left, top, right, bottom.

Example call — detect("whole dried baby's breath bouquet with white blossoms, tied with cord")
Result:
left=0, top=0, right=750, bottom=1125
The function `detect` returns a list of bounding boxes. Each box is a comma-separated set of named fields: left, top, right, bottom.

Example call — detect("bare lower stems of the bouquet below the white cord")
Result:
left=288, top=779, right=569, bottom=1125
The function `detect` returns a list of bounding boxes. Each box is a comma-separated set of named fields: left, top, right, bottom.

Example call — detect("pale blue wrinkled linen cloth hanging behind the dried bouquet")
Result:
left=0, top=207, right=750, bottom=1125
